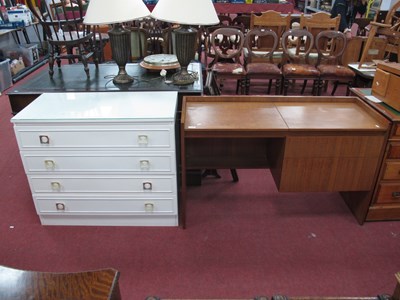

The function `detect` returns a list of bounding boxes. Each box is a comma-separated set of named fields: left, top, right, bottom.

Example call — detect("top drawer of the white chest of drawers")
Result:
left=15, top=123, right=175, bottom=151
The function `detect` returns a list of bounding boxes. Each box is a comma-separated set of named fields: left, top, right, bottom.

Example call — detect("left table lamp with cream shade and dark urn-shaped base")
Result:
left=83, top=0, right=150, bottom=84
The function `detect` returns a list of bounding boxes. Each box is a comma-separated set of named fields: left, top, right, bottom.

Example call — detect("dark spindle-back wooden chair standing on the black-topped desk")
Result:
left=26, top=0, right=102, bottom=78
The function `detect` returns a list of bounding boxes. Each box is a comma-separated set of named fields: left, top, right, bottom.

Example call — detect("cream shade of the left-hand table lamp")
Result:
left=83, top=0, right=150, bottom=25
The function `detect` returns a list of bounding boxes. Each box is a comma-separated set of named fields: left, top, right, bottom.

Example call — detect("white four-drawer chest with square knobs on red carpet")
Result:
left=11, top=92, right=178, bottom=226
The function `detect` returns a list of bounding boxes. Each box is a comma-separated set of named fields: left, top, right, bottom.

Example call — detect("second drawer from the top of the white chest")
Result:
left=21, top=151, right=176, bottom=174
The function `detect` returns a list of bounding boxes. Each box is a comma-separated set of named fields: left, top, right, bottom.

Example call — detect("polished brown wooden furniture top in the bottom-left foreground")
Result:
left=0, top=266, right=121, bottom=300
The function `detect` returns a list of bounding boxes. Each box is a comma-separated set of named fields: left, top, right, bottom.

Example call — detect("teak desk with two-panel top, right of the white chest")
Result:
left=180, top=96, right=389, bottom=227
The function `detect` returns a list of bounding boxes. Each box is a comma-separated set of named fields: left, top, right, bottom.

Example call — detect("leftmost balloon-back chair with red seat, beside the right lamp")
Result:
left=211, top=27, right=246, bottom=94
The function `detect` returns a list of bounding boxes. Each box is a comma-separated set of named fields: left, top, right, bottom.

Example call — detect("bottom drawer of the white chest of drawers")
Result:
left=34, top=196, right=177, bottom=215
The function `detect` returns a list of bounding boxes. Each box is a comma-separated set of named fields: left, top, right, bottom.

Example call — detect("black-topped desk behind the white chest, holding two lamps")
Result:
left=7, top=62, right=203, bottom=114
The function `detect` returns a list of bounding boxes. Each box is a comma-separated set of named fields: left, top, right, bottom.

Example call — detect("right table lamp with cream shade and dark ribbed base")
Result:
left=151, top=0, right=219, bottom=85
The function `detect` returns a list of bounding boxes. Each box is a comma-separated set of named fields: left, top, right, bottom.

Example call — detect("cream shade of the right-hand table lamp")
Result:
left=151, top=0, right=219, bottom=25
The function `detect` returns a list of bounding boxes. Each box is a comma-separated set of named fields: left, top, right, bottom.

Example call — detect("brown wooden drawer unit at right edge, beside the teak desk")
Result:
left=350, top=88, right=400, bottom=221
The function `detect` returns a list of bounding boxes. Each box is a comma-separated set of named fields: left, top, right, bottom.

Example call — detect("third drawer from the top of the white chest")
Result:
left=28, top=175, right=177, bottom=195
